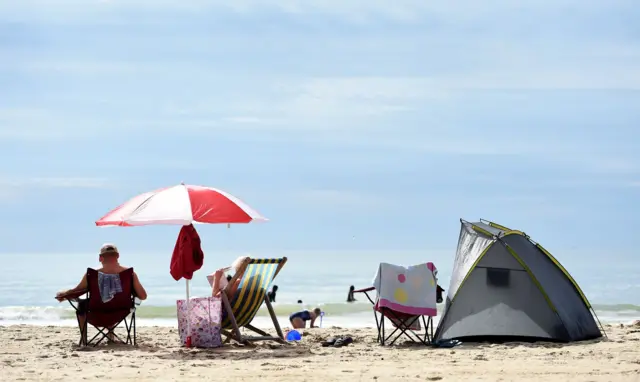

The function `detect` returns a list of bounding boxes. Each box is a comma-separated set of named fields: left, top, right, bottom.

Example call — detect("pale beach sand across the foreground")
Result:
left=0, top=324, right=640, bottom=382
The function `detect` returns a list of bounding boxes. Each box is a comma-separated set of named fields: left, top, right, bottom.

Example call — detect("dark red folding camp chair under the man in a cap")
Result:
left=58, top=268, right=136, bottom=346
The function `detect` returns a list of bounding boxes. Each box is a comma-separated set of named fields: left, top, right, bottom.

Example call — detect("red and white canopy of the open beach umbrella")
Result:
left=96, top=184, right=268, bottom=227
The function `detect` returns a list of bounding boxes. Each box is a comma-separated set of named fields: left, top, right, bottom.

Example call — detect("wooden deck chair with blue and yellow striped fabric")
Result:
left=221, top=257, right=287, bottom=344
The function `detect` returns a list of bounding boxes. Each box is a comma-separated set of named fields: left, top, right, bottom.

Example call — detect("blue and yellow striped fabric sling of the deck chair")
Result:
left=222, top=259, right=283, bottom=329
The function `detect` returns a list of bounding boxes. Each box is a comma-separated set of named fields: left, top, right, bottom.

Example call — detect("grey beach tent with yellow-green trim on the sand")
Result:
left=434, top=219, right=602, bottom=341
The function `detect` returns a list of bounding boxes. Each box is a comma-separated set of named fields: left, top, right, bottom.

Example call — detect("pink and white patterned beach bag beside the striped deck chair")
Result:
left=176, top=297, right=222, bottom=348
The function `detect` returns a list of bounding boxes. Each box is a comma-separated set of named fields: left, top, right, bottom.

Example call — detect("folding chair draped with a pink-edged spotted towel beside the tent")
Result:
left=354, top=263, right=438, bottom=345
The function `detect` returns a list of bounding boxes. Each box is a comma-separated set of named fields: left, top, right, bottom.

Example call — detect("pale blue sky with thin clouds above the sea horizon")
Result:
left=0, top=0, right=640, bottom=259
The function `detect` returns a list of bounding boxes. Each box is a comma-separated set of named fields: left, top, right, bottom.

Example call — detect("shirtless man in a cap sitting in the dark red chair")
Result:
left=56, top=244, right=147, bottom=344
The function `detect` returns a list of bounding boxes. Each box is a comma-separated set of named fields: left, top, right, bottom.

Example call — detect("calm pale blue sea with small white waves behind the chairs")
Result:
left=0, top=250, right=640, bottom=328
